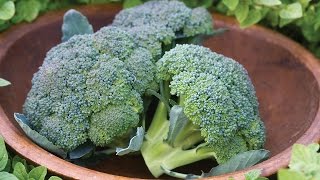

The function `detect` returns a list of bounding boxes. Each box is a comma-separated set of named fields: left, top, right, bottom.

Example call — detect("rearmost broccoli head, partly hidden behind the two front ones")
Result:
left=112, top=0, right=213, bottom=59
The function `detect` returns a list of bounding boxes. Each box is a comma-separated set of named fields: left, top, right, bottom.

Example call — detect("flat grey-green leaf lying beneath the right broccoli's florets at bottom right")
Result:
left=204, top=149, right=270, bottom=177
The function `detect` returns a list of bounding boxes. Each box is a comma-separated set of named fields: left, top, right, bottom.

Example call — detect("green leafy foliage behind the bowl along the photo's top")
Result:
left=0, top=0, right=320, bottom=57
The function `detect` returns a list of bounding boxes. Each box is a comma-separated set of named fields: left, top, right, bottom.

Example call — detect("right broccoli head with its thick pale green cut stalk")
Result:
left=141, top=45, right=265, bottom=177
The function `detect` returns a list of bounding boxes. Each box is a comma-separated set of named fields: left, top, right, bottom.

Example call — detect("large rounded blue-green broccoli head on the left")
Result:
left=23, top=27, right=158, bottom=152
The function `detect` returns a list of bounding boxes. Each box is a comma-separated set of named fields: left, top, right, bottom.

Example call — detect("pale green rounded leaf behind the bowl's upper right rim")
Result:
left=279, top=2, right=302, bottom=19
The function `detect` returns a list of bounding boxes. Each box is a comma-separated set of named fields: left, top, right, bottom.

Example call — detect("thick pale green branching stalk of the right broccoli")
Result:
left=140, top=102, right=215, bottom=177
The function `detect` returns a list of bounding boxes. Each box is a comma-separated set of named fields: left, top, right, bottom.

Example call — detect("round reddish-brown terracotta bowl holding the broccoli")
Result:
left=0, top=5, right=320, bottom=179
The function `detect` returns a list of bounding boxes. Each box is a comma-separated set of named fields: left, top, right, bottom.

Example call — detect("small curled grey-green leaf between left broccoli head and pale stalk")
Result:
left=116, top=127, right=144, bottom=156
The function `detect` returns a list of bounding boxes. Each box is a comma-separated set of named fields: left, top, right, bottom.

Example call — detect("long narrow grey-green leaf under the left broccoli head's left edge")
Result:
left=14, top=113, right=67, bottom=158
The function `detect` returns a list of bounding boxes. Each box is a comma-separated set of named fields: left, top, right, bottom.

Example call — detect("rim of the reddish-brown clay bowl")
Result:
left=0, top=4, right=320, bottom=180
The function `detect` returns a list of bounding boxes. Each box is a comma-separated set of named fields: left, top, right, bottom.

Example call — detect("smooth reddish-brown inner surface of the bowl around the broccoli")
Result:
left=0, top=10, right=319, bottom=178
